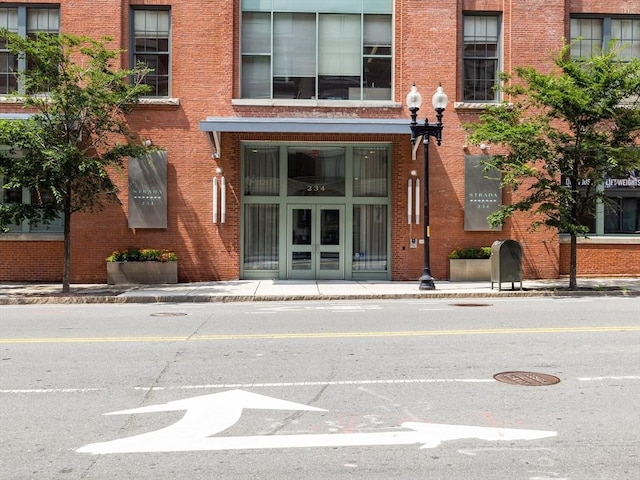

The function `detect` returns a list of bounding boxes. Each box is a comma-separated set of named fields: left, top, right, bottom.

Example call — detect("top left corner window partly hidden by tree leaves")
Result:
left=0, top=6, right=60, bottom=95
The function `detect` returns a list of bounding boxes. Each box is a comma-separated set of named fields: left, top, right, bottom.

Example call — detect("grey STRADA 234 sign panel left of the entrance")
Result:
left=129, top=151, right=167, bottom=228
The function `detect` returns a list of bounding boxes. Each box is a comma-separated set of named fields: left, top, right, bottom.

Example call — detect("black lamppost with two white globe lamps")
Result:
left=407, top=83, right=449, bottom=290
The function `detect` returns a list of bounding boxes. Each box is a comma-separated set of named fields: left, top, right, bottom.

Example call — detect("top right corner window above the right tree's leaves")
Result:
left=570, top=16, right=640, bottom=61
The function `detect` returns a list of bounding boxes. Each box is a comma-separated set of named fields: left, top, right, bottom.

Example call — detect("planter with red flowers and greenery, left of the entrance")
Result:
left=106, top=248, right=178, bottom=285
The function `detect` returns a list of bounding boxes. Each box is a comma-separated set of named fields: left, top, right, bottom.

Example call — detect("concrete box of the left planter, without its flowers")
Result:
left=107, top=262, right=178, bottom=285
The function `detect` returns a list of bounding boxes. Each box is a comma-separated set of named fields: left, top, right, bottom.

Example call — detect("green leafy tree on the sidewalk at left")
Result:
left=0, top=30, right=148, bottom=292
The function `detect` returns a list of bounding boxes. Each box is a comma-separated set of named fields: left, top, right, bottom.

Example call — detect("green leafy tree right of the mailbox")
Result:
left=465, top=43, right=640, bottom=289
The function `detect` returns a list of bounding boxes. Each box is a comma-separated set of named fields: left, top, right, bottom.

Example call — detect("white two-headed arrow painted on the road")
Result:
left=77, top=390, right=557, bottom=454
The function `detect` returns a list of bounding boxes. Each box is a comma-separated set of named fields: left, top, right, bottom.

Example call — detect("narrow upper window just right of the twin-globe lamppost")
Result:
left=462, top=15, right=500, bottom=102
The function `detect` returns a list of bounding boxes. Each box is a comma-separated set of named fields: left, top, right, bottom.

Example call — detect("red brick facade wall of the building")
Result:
left=0, top=0, right=640, bottom=283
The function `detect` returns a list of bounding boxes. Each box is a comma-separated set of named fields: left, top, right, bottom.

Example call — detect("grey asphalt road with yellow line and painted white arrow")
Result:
left=0, top=297, right=640, bottom=480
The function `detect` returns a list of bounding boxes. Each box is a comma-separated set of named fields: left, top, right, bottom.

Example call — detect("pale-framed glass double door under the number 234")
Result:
left=287, top=205, right=345, bottom=280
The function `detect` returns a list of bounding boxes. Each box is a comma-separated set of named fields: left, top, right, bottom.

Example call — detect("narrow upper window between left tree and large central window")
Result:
left=131, top=9, right=170, bottom=97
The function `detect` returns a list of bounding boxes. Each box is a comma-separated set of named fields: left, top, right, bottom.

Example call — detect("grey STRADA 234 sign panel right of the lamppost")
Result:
left=464, top=155, right=502, bottom=231
